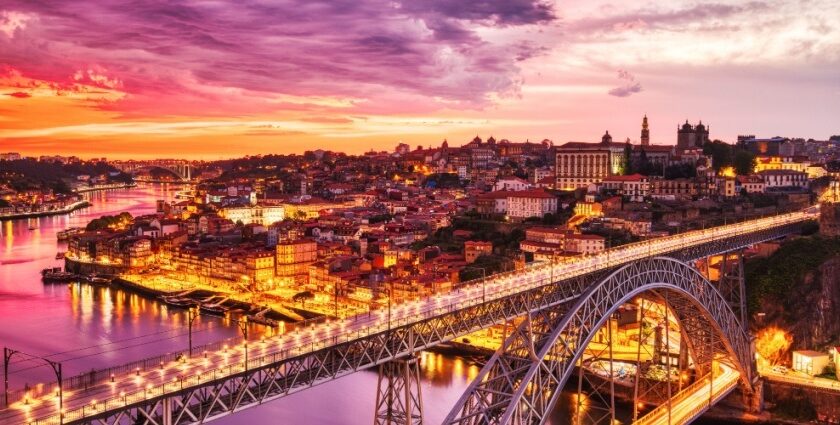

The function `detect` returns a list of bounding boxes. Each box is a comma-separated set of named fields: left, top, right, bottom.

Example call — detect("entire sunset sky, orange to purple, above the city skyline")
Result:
left=0, top=0, right=840, bottom=159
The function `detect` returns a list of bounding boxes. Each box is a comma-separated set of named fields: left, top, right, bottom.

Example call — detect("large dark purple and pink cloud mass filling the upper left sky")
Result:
left=0, top=0, right=554, bottom=114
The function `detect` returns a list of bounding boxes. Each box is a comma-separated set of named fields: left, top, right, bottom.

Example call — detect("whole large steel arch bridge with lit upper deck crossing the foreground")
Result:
left=0, top=213, right=813, bottom=425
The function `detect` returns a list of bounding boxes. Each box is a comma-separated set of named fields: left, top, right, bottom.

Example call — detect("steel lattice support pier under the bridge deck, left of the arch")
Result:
left=373, top=356, right=423, bottom=425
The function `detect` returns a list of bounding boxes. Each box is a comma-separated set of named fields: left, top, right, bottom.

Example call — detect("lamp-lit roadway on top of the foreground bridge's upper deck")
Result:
left=0, top=212, right=813, bottom=425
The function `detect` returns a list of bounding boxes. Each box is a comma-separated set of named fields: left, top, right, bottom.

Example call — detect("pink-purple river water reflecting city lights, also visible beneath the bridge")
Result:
left=0, top=185, right=612, bottom=425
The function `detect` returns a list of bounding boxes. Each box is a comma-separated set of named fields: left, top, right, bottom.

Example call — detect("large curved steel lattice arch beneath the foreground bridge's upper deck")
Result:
left=444, top=257, right=753, bottom=425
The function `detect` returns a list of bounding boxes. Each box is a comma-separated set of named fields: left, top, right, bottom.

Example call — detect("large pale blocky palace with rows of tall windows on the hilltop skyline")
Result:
left=554, top=131, right=627, bottom=190
